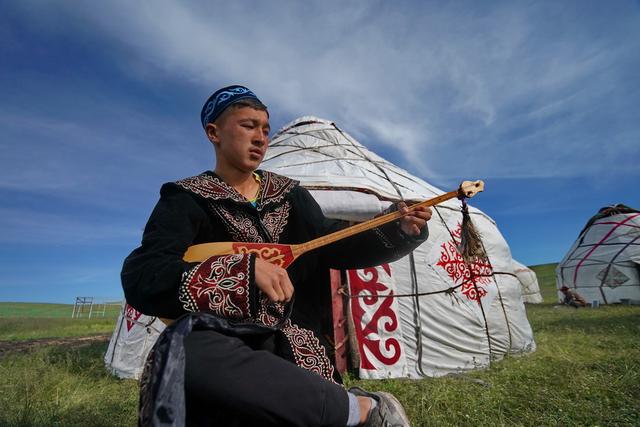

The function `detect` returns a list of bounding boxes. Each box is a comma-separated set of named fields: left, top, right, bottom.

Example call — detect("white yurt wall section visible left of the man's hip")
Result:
left=104, top=302, right=165, bottom=379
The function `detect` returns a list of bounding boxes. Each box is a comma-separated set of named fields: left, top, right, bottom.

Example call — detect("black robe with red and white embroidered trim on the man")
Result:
left=122, top=171, right=427, bottom=426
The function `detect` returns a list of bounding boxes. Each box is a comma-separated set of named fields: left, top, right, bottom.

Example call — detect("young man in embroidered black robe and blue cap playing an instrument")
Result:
left=122, top=86, right=431, bottom=427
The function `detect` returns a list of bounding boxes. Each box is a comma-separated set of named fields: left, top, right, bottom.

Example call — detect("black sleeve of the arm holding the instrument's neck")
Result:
left=300, top=187, right=428, bottom=270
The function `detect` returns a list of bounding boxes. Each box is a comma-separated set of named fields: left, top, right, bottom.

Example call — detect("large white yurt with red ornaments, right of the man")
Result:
left=261, top=117, right=535, bottom=378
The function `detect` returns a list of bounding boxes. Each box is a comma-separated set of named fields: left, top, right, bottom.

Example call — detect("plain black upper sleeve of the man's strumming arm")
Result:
left=121, top=184, right=207, bottom=318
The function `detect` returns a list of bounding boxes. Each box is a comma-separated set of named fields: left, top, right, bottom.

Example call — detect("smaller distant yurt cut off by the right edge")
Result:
left=556, top=205, right=640, bottom=304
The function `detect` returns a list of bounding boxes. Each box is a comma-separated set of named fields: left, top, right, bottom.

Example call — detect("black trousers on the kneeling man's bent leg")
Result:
left=184, top=330, right=349, bottom=427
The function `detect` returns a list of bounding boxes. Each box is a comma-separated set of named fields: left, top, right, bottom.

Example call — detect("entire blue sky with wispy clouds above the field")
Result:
left=0, top=0, right=640, bottom=302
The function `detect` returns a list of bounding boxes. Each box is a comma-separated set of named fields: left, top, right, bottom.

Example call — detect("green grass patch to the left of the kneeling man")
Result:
left=0, top=343, right=138, bottom=426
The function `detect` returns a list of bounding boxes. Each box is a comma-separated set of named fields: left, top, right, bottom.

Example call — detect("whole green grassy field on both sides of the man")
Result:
left=0, top=265, right=640, bottom=426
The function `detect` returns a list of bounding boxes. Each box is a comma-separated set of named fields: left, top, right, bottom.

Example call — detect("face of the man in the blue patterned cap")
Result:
left=207, top=107, right=271, bottom=172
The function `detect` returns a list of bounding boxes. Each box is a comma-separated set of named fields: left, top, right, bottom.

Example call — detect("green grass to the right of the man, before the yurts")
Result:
left=351, top=304, right=640, bottom=426
